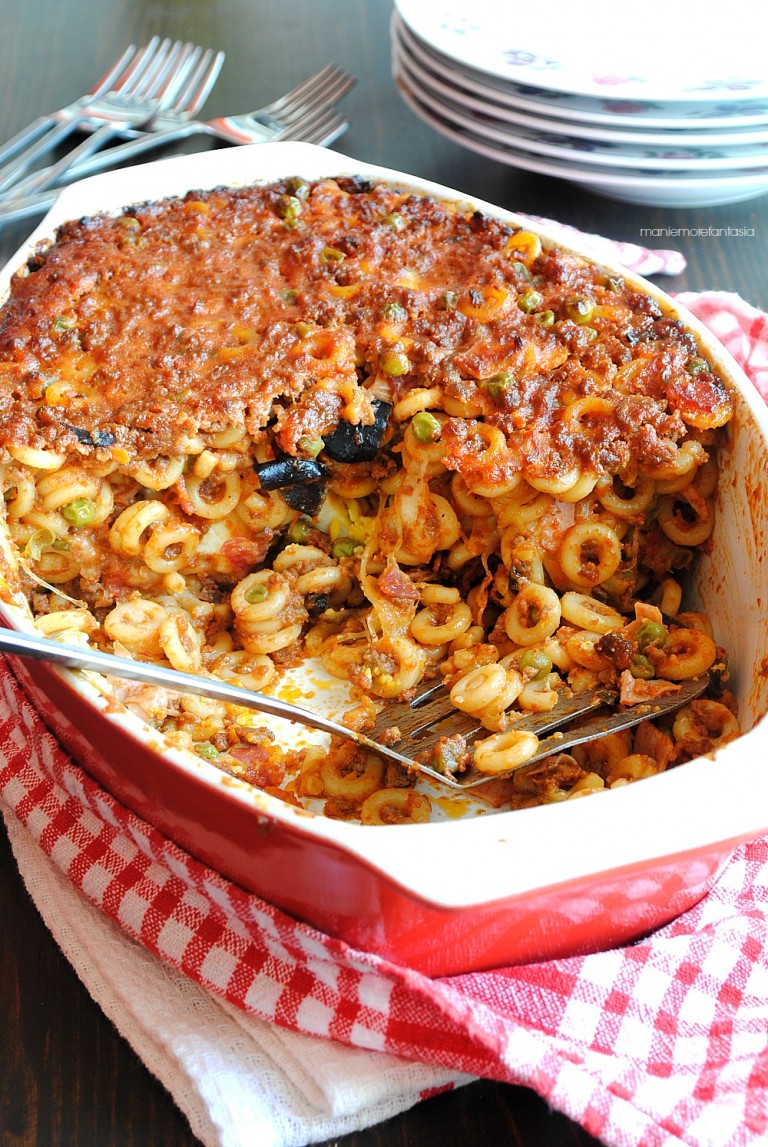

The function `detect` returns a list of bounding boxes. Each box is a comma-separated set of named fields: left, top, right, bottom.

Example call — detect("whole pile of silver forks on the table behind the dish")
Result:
left=0, top=37, right=354, bottom=224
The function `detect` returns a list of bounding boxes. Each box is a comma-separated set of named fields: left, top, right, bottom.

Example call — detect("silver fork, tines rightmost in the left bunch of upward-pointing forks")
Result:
left=2, top=42, right=225, bottom=201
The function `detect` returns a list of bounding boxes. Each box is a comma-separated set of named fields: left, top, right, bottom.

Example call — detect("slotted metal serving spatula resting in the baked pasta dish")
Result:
left=0, top=630, right=710, bottom=789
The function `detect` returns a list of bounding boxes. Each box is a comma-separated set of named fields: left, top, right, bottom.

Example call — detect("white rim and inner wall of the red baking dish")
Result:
left=0, top=143, right=768, bottom=907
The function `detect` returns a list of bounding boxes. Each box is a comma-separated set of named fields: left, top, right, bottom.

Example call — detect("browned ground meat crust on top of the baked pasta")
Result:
left=0, top=179, right=730, bottom=477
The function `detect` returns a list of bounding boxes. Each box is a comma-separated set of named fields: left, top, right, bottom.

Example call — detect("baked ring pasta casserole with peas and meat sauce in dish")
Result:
left=0, top=178, right=738, bottom=824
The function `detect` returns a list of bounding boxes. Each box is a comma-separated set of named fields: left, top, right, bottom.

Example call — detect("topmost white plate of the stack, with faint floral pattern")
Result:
left=395, top=0, right=768, bottom=103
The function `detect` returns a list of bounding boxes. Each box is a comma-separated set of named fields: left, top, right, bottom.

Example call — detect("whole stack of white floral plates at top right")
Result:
left=392, top=0, right=768, bottom=206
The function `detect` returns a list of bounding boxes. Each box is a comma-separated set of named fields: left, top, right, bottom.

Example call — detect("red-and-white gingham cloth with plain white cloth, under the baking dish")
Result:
left=0, top=270, right=768, bottom=1147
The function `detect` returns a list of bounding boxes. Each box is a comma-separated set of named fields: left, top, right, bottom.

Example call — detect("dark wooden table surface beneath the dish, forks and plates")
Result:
left=0, top=0, right=768, bottom=1147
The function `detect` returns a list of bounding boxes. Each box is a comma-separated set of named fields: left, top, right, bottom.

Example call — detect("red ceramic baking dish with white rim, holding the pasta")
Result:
left=0, top=143, right=768, bottom=975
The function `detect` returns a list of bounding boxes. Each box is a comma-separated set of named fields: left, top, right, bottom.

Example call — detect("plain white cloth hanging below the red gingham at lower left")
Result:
left=3, top=809, right=473, bottom=1147
